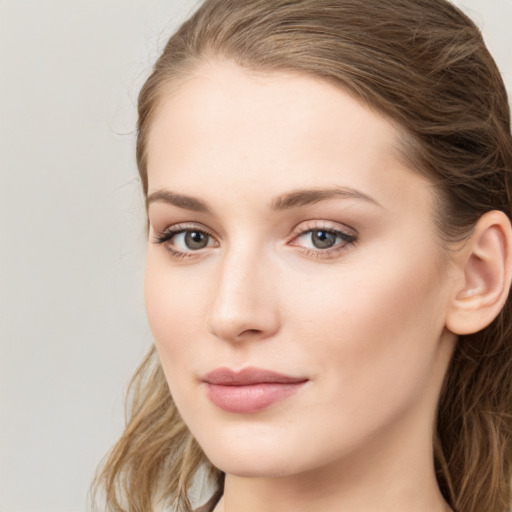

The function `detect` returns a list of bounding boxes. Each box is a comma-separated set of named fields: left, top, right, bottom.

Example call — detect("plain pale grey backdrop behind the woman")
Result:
left=0, top=0, right=512, bottom=512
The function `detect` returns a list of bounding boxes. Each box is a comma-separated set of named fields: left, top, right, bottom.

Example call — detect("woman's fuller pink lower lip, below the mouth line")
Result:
left=207, top=381, right=306, bottom=414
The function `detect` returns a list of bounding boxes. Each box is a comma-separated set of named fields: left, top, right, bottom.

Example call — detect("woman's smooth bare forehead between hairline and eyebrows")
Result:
left=148, top=61, right=434, bottom=217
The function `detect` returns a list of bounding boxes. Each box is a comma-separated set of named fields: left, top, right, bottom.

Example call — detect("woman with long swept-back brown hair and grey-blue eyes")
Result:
left=93, top=0, right=512, bottom=512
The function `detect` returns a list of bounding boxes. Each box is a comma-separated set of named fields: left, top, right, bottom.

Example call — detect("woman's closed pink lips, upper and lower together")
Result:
left=202, top=367, right=308, bottom=414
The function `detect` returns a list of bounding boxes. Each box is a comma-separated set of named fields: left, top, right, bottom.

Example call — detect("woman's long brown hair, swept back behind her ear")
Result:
left=92, top=0, right=512, bottom=512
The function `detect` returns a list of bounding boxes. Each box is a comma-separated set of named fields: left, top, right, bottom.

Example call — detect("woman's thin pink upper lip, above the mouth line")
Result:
left=202, top=367, right=308, bottom=386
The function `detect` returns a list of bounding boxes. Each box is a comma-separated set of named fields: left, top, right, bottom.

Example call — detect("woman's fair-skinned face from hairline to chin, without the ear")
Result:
left=146, top=62, right=454, bottom=476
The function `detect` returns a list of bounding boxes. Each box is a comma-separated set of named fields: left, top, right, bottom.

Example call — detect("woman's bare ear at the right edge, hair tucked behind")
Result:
left=446, top=210, right=512, bottom=335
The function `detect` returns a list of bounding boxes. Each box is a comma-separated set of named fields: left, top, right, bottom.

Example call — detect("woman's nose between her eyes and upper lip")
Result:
left=206, top=245, right=280, bottom=343
